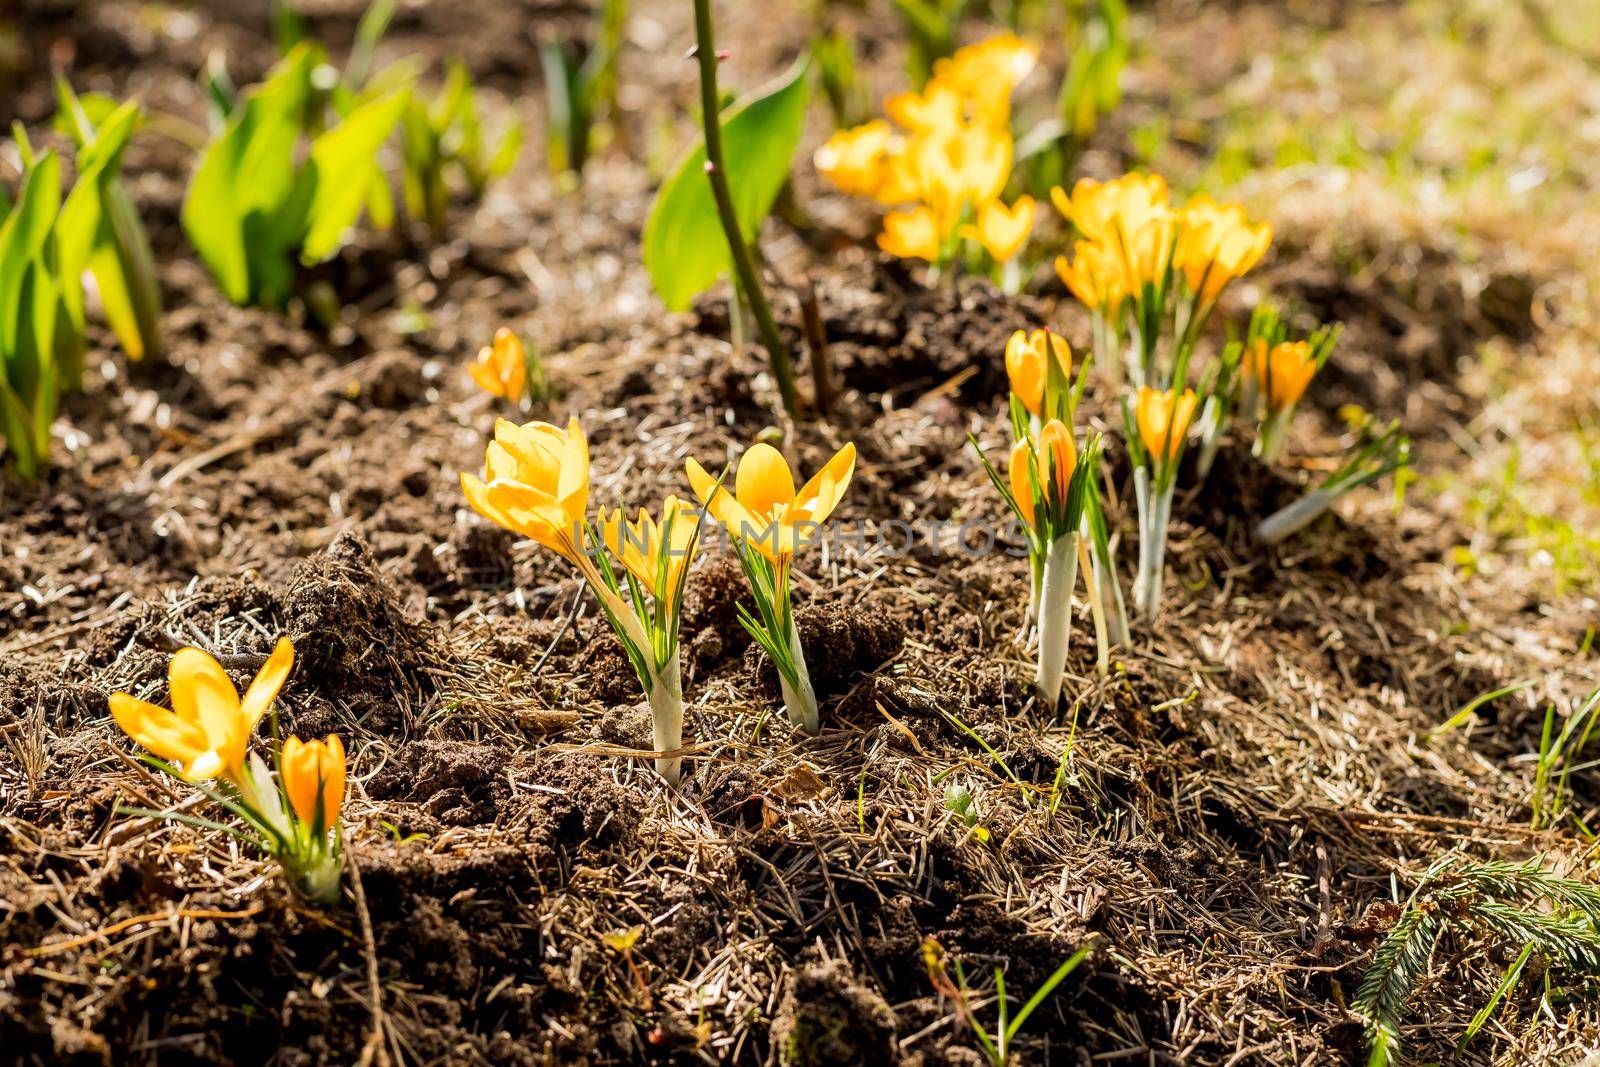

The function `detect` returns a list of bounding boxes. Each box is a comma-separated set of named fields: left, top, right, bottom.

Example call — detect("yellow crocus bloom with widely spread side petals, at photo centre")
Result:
left=688, top=442, right=856, bottom=565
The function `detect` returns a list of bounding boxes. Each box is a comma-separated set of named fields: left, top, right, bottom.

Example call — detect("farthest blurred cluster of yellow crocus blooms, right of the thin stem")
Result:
left=814, top=34, right=1038, bottom=279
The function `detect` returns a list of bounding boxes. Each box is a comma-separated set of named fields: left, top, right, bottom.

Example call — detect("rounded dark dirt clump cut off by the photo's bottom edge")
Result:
left=773, top=960, right=899, bottom=1067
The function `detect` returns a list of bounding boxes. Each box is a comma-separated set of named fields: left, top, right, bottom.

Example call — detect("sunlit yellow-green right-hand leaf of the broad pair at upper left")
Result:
left=301, top=91, right=411, bottom=266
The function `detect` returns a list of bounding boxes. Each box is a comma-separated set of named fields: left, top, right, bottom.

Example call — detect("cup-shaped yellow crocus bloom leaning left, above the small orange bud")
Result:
left=461, top=419, right=589, bottom=566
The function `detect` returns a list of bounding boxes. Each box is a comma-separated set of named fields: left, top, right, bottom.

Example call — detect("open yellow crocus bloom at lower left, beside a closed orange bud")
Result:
left=110, top=637, right=294, bottom=784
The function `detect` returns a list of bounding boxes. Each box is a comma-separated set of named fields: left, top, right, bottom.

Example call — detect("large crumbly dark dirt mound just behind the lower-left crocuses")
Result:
left=283, top=533, right=442, bottom=733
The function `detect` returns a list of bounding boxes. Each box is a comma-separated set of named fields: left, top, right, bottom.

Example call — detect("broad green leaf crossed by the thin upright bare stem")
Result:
left=645, top=59, right=810, bottom=310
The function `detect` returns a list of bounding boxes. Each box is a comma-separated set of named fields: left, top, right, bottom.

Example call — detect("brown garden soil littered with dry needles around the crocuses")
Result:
left=0, top=0, right=1594, bottom=1064
